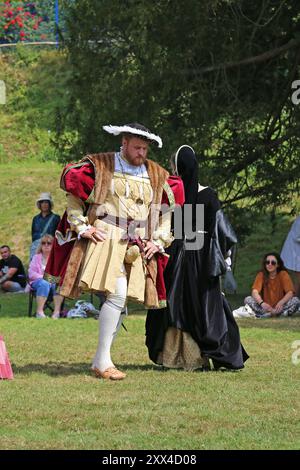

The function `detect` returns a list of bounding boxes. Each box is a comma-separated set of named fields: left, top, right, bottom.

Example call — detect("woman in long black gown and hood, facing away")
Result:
left=146, top=145, right=248, bottom=370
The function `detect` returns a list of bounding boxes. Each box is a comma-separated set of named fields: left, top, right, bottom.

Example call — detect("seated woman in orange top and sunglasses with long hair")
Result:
left=244, top=252, right=300, bottom=318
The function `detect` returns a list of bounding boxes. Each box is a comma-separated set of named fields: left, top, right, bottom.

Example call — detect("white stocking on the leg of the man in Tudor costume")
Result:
left=92, top=277, right=127, bottom=372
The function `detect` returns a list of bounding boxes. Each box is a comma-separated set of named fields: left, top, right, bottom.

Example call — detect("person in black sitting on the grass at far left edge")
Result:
left=0, top=245, right=26, bottom=292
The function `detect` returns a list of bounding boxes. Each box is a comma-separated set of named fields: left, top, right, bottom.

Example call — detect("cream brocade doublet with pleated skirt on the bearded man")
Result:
left=67, top=154, right=172, bottom=303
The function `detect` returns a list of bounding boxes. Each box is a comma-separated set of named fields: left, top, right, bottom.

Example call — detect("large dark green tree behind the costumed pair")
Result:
left=56, top=0, right=300, bottom=237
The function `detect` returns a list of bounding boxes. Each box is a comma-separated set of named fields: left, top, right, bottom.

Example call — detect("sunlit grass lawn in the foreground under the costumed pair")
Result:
left=0, top=294, right=300, bottom=450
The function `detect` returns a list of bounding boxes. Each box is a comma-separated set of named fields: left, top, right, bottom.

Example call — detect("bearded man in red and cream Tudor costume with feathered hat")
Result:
left=45, top=123, right=184, bottom=380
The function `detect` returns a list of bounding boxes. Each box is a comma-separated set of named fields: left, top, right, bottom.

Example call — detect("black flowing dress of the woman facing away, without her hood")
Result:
left=146, top=187, right=249, bottom=369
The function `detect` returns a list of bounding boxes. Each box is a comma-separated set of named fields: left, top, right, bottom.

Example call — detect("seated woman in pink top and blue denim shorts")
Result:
left=28, top=234, right=63, bottom=319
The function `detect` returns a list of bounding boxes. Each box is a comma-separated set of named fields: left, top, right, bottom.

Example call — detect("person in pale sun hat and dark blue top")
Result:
left=30, top=193, right=60, bottom=261
